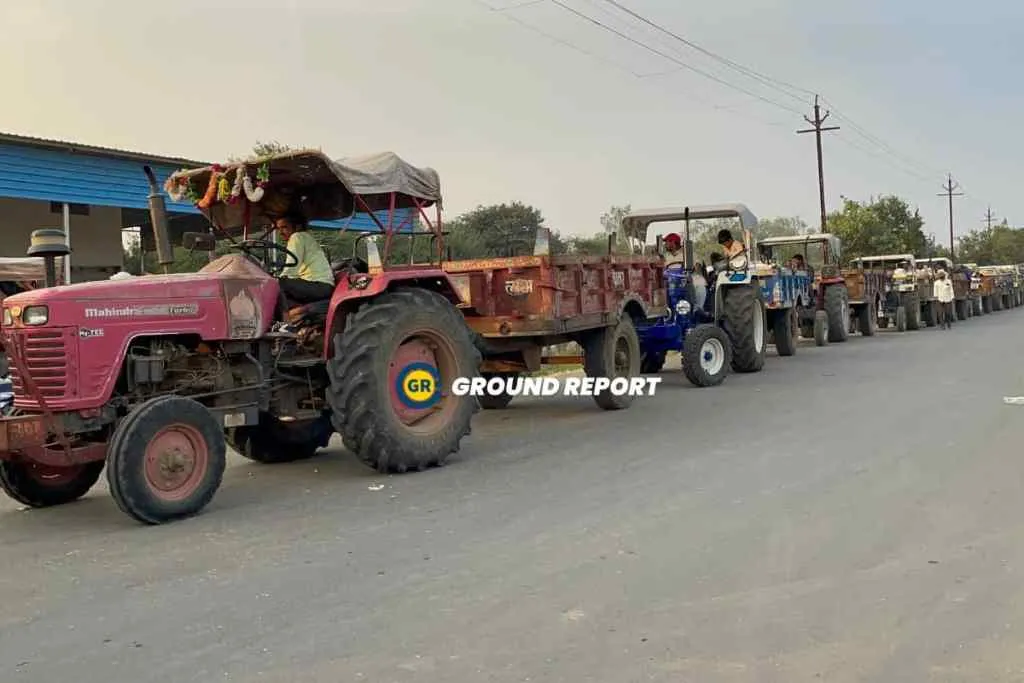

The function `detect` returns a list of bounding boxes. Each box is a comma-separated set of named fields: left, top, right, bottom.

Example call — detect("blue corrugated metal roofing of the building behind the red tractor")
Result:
left=0, top=135, right=412, bottom=232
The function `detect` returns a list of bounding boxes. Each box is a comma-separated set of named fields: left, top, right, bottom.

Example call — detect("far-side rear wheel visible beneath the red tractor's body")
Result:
left=230, top=413, right=334, bottom=465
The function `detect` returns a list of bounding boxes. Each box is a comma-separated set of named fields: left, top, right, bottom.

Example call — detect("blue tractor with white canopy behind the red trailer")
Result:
left=622, top=204, right=766, bottom=387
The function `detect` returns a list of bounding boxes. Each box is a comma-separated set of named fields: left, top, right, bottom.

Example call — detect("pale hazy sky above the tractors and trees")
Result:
left=0, top=0, right=1024, bottom=244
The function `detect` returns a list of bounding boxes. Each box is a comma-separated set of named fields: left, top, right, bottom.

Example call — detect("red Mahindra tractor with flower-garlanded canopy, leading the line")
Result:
left=0, top=151, right=480, bottom=524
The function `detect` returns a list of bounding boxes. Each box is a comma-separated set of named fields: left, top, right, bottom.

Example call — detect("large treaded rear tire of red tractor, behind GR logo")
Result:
left=328, top=288, right=480, bottom=473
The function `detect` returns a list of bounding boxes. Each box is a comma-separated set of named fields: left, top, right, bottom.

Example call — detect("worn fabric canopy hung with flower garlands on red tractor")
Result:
left=164, top=150, right=441, bottom=230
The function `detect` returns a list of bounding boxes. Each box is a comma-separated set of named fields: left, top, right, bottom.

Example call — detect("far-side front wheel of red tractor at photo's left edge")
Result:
left=0, top=460, right=103, bottom=508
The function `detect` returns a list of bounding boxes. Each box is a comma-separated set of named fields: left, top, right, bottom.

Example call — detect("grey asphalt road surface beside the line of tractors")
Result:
left=0, top=309, right=1024, bottom=683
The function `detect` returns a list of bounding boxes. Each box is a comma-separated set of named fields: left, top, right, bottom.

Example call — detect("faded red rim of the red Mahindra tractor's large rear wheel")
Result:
left=388, top=329, right=459, bottom=434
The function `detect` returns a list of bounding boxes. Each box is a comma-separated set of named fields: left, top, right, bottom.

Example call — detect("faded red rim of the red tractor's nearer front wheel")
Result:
left=145, top=423, right=210, bottom=501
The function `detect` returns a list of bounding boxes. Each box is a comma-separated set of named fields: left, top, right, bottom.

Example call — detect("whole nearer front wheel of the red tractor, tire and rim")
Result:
left=106, top=394, right=227, bottom=524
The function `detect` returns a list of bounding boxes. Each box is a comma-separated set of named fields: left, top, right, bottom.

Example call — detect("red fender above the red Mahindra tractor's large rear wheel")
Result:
left=324, top=268, right=468, bottom=358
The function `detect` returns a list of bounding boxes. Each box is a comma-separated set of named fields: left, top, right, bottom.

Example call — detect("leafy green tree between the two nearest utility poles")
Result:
left=828, top=195, right=935, bottom=259
